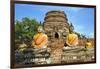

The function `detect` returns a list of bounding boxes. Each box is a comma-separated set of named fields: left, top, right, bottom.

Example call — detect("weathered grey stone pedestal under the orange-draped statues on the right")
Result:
left=62, top=46, right=94, bottom=63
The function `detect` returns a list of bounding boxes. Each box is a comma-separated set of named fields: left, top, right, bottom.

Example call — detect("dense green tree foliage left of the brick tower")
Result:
left=15, top=17, right=40, bottom=44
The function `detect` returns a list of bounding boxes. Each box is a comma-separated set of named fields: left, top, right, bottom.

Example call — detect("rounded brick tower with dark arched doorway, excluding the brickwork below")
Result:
left=44, top=10, right=69, bottom=39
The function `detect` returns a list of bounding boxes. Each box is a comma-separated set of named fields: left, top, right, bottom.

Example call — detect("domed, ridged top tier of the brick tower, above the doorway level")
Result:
left=44, top=11, right=68, bottom=25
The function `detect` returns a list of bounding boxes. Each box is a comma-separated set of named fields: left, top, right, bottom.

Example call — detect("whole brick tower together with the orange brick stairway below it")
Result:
left=43, top=10, right=69, bottom=63
